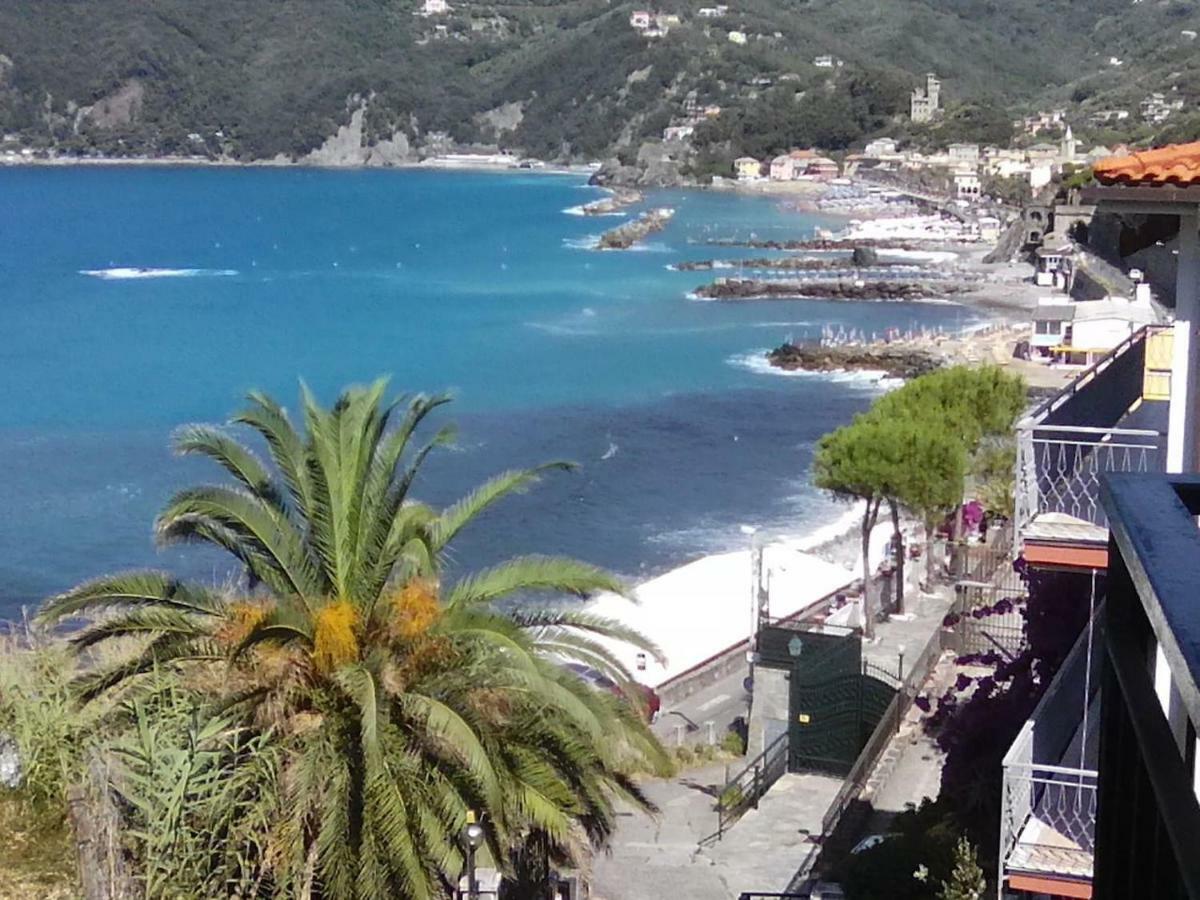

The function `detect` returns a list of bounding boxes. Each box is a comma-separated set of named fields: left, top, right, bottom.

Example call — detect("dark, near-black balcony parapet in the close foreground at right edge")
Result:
left=1093, top=475, right=1200, bottom=900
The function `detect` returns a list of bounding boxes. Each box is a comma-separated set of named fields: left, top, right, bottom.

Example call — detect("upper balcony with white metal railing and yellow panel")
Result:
left=1014, top=326, right=1170, bottom=568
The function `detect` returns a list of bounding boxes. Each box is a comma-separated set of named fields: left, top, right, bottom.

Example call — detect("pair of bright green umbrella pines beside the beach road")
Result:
left=812, top=366, right=1025, bottom=637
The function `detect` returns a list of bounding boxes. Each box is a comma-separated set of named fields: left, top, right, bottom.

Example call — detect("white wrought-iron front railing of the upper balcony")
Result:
left=1015, top=425, right=1163, bottom=542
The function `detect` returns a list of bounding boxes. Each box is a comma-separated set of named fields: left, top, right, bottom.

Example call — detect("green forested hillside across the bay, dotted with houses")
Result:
left=0, top=0, right=1200, bottom=160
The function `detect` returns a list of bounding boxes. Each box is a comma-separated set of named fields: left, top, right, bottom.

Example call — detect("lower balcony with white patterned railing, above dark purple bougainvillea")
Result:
left=1000, top=617, right=1103, bottom=898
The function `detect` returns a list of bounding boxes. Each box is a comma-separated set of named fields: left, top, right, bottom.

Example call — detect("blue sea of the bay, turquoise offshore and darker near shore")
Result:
left=0, top=167, right=973, bottom=618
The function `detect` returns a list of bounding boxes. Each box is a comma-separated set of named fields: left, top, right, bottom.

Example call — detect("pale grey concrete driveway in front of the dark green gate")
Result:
left=592, top=766, right=841, bottom=900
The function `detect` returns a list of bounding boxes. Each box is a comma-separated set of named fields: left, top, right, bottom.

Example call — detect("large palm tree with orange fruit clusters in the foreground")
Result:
left=41, top=380, right=667, bottom=898
